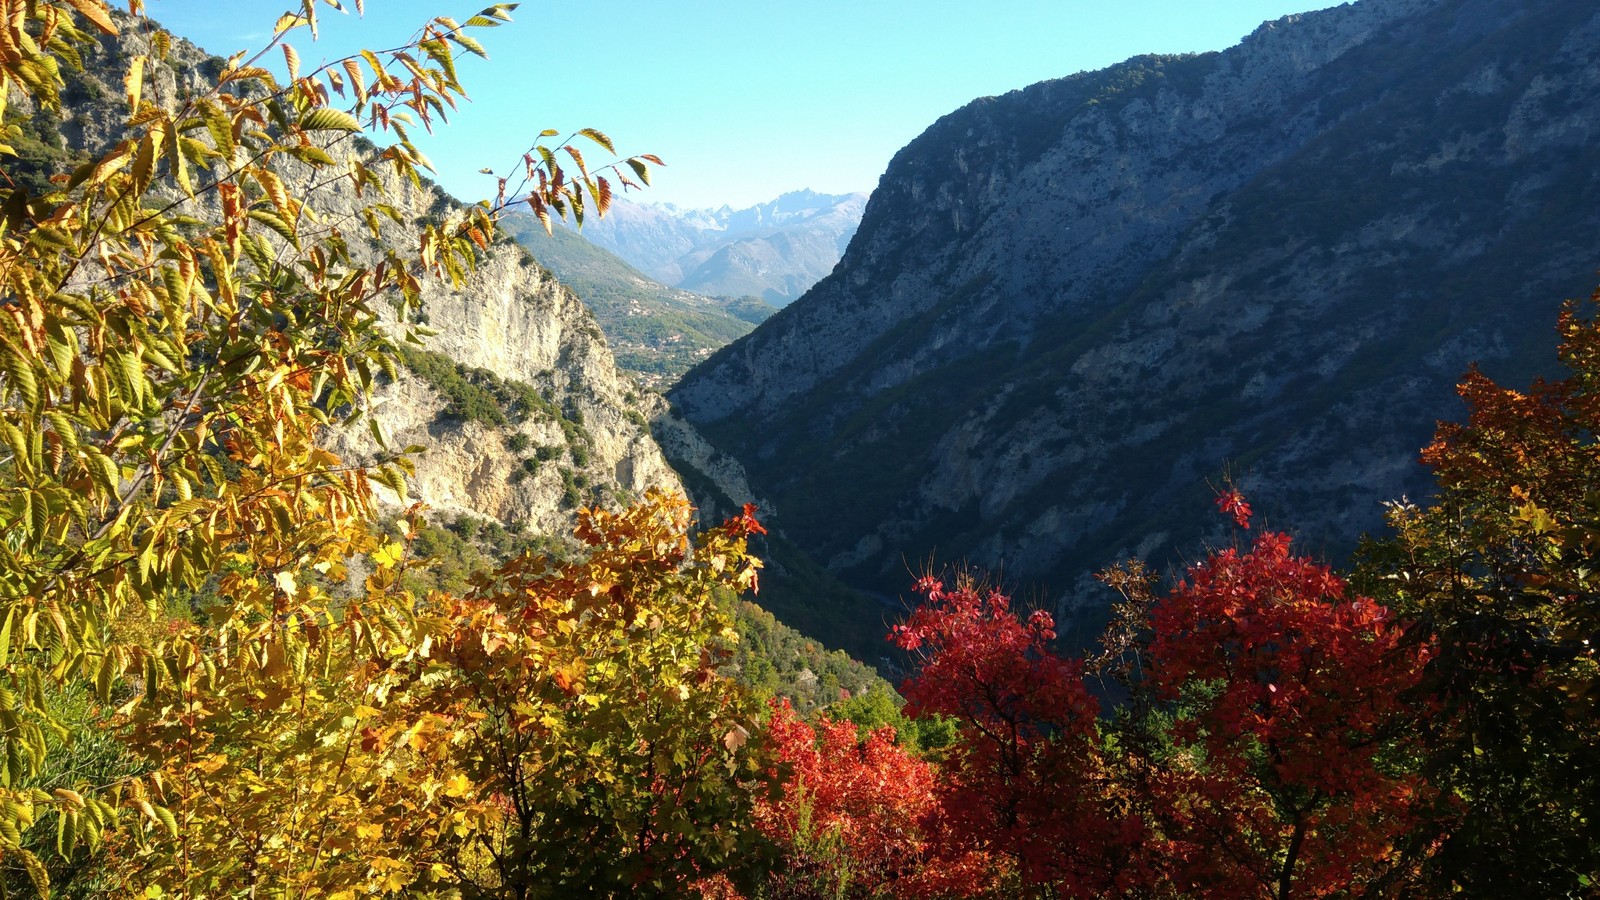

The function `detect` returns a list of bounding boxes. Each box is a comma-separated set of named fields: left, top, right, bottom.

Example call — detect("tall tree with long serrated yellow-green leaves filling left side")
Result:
left=0, top=0, right=648, bottom=895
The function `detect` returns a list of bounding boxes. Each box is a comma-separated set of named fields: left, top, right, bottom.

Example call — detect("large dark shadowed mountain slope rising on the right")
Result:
left=669, top=0, right=1600, bottom=642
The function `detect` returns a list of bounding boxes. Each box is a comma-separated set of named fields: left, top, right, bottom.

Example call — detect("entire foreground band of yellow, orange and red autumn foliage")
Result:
left=0, top=0, right=1600, bottom=900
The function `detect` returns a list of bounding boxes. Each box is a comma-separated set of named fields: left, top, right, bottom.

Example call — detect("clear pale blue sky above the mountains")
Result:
left=146, top=0, right=1333, bottom=207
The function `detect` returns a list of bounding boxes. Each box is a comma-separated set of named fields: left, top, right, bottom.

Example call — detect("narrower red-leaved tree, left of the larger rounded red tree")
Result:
left=891, top=578, right=1142, bottom=897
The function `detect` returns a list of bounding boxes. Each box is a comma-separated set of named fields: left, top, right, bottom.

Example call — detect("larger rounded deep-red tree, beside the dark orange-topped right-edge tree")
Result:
left=1146, top=492, right=1429, bottom=898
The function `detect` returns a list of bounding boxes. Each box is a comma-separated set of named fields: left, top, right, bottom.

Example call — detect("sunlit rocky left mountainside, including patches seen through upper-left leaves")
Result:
left=31, top=16, right=682, bottom=535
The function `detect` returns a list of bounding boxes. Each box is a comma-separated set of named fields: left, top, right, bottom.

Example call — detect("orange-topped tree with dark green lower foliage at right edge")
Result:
left=1357, top=293, right=1600, bottom=897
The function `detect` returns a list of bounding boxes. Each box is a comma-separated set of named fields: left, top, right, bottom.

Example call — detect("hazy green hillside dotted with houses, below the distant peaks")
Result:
left=501, top=211, right=778, bottom=388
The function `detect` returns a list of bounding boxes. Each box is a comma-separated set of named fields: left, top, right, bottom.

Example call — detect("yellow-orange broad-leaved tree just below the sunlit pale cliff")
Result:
left=412, top=492, right=766, bottom=900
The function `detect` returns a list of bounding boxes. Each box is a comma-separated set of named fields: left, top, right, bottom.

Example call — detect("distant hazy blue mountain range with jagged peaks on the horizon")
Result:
left=584, top=191, right=867, bottom=306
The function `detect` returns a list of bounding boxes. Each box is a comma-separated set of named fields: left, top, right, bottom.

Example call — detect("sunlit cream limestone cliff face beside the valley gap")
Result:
left=316, top=186, right=683, bottom=533
